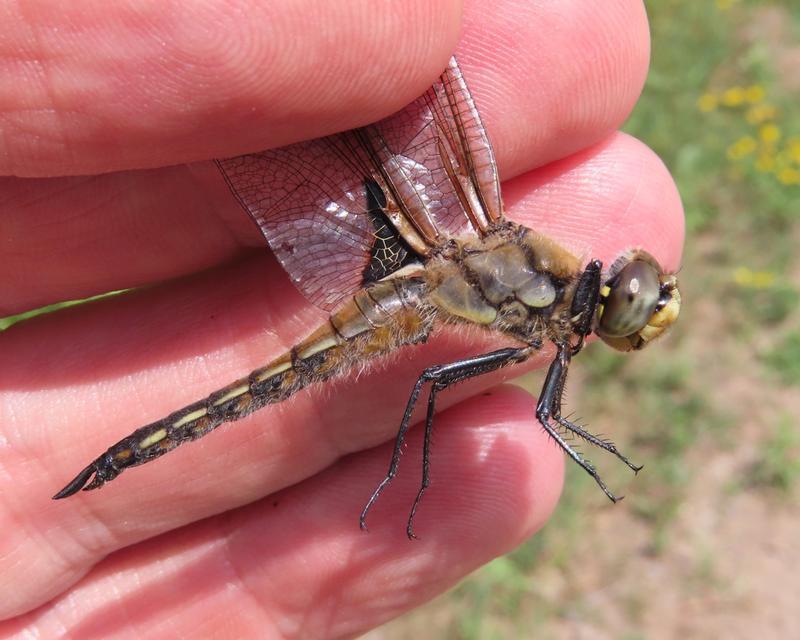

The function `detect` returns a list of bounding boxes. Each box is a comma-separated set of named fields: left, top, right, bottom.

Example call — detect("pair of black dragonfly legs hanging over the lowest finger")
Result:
left=359, top=347, right=533, bottom=538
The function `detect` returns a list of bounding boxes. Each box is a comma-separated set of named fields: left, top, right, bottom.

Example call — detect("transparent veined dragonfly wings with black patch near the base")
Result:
left=217, top=59, right=502, bottom=310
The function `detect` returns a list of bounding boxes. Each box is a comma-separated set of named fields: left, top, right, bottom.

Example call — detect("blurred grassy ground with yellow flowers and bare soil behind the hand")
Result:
left=376, top=0, right=800, bottom=640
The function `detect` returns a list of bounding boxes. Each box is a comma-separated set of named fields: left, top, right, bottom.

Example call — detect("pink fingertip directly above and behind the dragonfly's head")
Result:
left=504, top=133, right=684, bottom=271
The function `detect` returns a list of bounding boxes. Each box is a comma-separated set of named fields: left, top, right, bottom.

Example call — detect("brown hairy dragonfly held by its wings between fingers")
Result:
left=54, top=58, right=681, bottom=538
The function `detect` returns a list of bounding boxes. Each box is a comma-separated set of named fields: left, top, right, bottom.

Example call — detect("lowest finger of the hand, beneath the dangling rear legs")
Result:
left=0, top=387, right=563, bottom=638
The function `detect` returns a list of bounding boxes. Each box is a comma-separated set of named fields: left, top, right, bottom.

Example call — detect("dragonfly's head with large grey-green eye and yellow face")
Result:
left=595, top=249, right=681, bottom=351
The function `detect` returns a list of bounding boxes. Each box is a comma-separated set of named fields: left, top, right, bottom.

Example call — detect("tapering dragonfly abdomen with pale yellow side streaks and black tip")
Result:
left=54, top=277, right=433, bottom=499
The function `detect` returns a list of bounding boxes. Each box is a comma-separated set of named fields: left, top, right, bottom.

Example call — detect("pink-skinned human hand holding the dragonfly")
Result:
left=0, top=0, right=683, bottom=638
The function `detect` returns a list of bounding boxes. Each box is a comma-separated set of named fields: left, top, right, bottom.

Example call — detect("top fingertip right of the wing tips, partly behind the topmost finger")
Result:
left=457, top=0, right=650, bottom=180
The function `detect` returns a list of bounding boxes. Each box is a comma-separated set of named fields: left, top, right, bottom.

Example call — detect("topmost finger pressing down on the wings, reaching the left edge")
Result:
left=0, top=0, right=460, bottom=176
